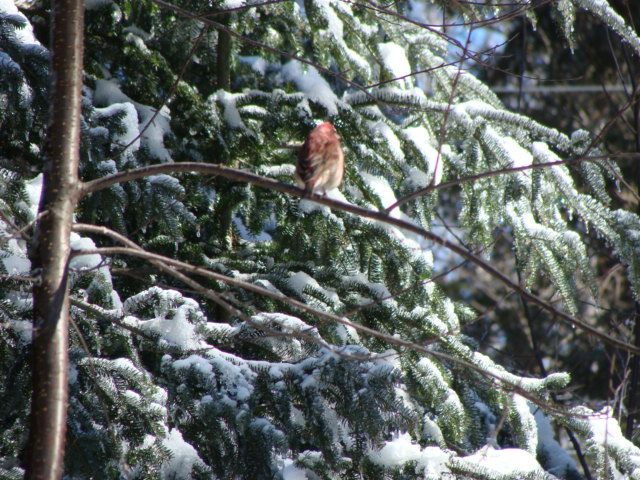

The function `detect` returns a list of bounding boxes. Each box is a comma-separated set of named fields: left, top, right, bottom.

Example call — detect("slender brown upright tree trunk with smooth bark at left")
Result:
left=25, top=0, right=84, bottom=480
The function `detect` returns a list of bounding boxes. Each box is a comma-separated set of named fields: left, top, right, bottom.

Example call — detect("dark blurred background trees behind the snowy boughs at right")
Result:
left=480, top=1, right=640, bottom=428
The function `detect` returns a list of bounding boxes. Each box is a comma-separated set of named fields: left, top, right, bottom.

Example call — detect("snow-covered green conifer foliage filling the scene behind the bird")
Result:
left=0, top=0, right=640, bottom=479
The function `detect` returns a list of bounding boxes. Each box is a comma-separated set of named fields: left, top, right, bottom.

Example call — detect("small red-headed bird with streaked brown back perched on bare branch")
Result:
left=295, top=122, right=344, bottom=195
